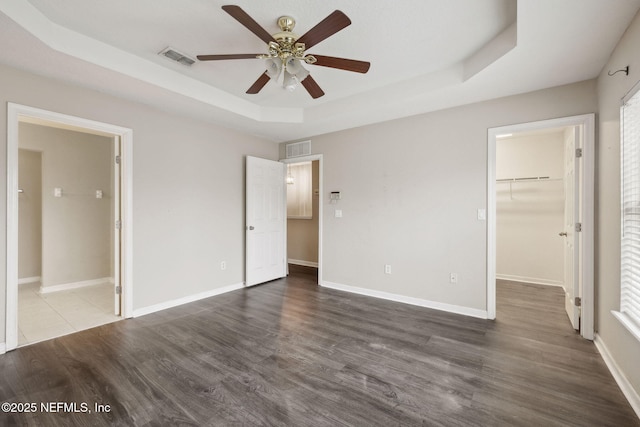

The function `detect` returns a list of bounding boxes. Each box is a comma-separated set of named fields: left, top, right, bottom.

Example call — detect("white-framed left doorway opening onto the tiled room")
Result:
left=6, top=103, right=132, bottom=350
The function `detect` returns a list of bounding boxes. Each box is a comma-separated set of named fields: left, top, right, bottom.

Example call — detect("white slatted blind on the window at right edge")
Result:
left=620, top=82, right=640, bottom=328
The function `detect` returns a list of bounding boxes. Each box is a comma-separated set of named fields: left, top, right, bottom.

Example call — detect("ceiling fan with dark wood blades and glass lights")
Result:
left=197, top=5, right=371, bottom=99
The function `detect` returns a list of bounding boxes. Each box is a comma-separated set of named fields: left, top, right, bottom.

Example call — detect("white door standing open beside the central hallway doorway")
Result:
left=245, top=156, right=287, bottom=286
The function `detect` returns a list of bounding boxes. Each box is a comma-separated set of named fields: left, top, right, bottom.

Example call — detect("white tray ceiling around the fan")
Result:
left=0, top=0, right=640, bottom=141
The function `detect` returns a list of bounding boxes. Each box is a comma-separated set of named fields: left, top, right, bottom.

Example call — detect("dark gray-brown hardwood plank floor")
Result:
left=0, top=267, right=640, bottom=426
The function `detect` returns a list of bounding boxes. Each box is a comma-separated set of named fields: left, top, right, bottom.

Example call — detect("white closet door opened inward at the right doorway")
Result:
left=560, top=126, right=581, bottom=330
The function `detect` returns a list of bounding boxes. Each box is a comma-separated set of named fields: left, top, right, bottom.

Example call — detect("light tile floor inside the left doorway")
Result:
left=18, top=282, right=121, bottom=346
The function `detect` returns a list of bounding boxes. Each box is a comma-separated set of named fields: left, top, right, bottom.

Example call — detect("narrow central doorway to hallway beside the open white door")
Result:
left=282, top=155, right=323, bottom=284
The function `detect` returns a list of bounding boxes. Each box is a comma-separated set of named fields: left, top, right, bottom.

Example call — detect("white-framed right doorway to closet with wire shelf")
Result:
left=487, top=114, right=594, bottom=339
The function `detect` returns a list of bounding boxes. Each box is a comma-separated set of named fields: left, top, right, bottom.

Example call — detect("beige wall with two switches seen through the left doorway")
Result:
left=18, top=123, right=113, bottom=289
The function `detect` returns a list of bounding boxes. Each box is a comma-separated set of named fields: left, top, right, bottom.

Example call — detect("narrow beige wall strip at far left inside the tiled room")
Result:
left=18, top=150, right=42, bottom=279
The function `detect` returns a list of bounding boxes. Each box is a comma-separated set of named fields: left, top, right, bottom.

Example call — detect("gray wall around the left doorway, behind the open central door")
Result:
left=0, top=61, right=278, bottom=342
